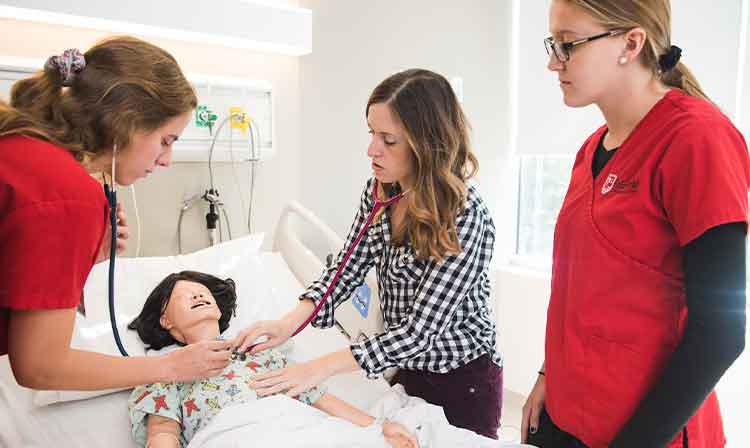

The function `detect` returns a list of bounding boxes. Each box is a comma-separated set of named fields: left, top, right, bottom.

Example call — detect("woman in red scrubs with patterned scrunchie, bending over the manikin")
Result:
left=0, top=37, right=235, bottom=390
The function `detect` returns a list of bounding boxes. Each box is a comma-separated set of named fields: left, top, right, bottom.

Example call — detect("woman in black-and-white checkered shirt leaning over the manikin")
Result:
left=235, top=69, right=502, bottom=438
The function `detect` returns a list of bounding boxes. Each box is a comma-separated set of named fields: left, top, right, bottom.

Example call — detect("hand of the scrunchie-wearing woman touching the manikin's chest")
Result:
left=163, top=341, right=232, bottom=382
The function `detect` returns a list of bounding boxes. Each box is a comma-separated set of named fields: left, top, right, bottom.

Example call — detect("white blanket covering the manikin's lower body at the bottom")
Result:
left=188, top=386, right=524, bottom=448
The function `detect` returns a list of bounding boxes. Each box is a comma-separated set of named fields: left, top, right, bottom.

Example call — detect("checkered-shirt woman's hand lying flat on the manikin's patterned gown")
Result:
left=247, top=359, right=331, bottom=397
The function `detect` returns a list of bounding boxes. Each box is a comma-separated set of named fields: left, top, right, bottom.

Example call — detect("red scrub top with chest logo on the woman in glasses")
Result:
left=545, top=90, right=750, bottom=448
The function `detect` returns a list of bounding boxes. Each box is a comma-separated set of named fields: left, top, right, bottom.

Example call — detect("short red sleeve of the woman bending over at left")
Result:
left=0, top=200, right=106, bottom=310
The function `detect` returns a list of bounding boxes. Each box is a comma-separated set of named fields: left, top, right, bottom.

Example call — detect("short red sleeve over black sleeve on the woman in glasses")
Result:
left=657, top=120, right=750, bottom=246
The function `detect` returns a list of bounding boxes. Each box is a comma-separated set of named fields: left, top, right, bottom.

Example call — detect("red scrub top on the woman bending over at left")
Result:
left=0, top=135, right=108, bottom=355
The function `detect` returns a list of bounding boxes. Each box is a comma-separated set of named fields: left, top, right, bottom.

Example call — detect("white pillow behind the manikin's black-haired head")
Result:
left=34, top=234, right=284, bottom=406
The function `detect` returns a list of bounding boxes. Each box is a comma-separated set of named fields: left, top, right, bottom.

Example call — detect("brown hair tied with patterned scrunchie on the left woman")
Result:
left=0, top=36, right=198, bottom=163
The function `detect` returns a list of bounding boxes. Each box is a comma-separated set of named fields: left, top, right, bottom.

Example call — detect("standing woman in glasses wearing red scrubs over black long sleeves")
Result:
left=522, top=0, right=750, bottom=448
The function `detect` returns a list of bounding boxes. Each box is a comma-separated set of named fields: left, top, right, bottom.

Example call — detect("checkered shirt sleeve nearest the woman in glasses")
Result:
left=350, top=196, right=495, bottom=376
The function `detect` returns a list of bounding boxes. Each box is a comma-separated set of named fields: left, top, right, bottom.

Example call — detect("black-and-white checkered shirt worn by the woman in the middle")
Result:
left=302, top=179, right=502, bottom=377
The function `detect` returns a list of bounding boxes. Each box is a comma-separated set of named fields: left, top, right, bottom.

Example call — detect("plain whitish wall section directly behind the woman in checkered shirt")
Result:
left=300, top=0, right=510, bottom=245
